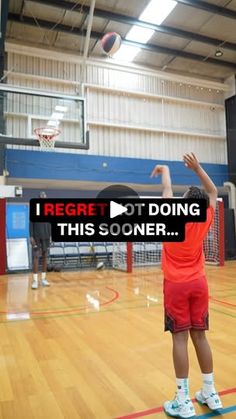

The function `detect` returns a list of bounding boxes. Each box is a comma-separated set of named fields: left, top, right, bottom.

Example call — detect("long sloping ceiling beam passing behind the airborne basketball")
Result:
left=8, top=13, right=236, bottom=70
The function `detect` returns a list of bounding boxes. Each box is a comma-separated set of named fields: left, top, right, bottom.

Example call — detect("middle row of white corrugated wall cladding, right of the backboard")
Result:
left=87, top=88, right=225, bottom=136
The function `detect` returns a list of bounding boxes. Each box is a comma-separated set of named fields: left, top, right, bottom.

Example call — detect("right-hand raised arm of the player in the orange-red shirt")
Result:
left=183, top=153, right=217, bottom=208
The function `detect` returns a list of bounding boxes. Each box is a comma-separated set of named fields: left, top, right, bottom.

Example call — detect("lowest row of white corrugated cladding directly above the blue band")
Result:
left=89, top=127, right=226, bottom=164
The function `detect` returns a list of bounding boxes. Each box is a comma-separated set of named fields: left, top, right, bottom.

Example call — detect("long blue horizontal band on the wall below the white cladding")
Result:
left=6, top=149, right=228, bottom=186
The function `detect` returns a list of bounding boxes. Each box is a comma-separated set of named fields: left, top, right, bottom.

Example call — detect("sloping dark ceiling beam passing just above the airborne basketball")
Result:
left=27, top=0, right=236, bottom=51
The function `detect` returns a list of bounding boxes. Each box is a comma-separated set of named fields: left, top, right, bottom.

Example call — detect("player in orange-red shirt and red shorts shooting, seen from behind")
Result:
left=151, top=153, right=222, bottom=418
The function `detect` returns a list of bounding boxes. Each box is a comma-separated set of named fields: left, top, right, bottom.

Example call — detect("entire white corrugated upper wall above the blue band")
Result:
left=4, top=52, right=227, bottom=163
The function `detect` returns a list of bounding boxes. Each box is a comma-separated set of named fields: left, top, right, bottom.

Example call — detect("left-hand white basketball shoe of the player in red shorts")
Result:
left=164, top=396, right=196, bottom=419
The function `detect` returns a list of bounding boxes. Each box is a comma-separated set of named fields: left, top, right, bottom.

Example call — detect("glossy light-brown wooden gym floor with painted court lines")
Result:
left=0, top=262, right=236, bottom=419
